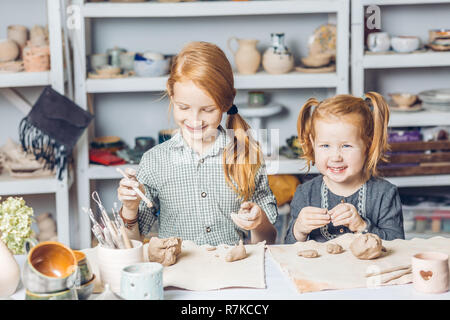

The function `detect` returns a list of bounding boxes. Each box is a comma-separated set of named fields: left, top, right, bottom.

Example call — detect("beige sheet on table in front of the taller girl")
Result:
left=81, top=240, right=266, bottom=293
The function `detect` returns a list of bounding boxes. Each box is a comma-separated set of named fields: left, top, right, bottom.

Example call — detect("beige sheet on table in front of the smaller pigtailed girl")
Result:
left=268, top=233, right=450, bottom=293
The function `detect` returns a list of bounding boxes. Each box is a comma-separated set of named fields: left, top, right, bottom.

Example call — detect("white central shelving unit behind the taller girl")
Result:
left=72, top=0, right=350, bottom=247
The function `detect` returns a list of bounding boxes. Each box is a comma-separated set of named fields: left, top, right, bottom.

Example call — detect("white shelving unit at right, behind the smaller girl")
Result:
left=351, top=0, right=450, bottom=187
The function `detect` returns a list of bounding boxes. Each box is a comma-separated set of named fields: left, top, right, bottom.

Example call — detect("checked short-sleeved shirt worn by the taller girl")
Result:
left=137, top=127, right=278, bottom=245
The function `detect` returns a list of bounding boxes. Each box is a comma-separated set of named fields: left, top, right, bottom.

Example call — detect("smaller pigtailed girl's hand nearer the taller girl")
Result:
left=293, top=207, right=331, bottom=241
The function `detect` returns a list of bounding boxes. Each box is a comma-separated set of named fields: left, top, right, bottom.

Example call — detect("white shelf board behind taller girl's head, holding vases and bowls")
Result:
left=86, top=71, right=338, bottom=93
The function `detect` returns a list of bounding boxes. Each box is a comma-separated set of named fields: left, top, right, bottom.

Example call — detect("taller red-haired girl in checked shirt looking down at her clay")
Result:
left=118, top=42, right=277, bottom=245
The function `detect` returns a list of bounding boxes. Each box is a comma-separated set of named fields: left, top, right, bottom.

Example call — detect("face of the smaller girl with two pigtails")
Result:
left=312, top=118, right=365, bottom=182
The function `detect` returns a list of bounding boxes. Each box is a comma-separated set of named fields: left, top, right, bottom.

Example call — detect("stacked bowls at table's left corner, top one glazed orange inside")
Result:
left=22, top=241, right=94, bottom=300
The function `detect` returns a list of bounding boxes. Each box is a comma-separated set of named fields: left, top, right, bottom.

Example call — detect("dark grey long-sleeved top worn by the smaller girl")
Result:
left=285, top=175, right=405, bottom=244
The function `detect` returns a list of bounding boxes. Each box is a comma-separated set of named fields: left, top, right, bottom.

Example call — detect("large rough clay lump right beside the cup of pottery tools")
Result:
left=148, top=237, right=182, bottom=267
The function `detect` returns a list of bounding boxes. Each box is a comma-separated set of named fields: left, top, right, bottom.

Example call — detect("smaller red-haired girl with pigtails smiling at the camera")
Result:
left=285, top=92, right=405, bottom=243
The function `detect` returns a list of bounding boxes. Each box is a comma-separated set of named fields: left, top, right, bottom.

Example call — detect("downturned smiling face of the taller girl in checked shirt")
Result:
left=171, top=81, right=222, bottom=139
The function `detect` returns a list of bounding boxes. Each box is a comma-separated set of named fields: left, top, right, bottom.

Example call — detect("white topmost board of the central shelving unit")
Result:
left=82, top=0, right=340, bottom=18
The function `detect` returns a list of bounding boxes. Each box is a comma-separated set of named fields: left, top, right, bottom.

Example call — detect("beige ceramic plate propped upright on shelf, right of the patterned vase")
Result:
left=308, top=24, right=336, bottom=56
